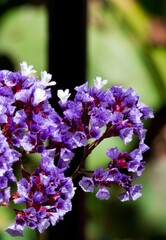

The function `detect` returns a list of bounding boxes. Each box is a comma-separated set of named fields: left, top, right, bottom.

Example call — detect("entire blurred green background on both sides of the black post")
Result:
left=0, top=0, right=166, bottom=240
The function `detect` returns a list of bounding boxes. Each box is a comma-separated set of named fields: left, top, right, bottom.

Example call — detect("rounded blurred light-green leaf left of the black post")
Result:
left=0, top=5, right=47, bottom=72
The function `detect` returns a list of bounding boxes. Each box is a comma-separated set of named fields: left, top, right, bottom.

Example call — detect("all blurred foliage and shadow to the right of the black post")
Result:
left=86, top=0, right=166, bottom=240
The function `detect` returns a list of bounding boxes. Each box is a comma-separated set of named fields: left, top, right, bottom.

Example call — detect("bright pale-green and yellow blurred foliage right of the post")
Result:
left=87, top=0, right=166, bottom=173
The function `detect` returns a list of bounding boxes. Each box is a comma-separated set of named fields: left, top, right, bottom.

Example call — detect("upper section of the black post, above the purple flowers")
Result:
left=48, top=0, right=86, bottom=105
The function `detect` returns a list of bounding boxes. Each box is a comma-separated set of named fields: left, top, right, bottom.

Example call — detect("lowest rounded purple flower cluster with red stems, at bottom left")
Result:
left=6, top=157, right=75, bottom=236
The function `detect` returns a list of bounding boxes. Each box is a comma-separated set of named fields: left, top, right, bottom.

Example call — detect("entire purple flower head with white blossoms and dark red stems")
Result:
left=0, top=62, right=153, bottom=236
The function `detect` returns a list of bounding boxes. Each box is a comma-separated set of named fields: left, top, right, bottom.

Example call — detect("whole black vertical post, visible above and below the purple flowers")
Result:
left=48, top=0, right=86, bottom=240
